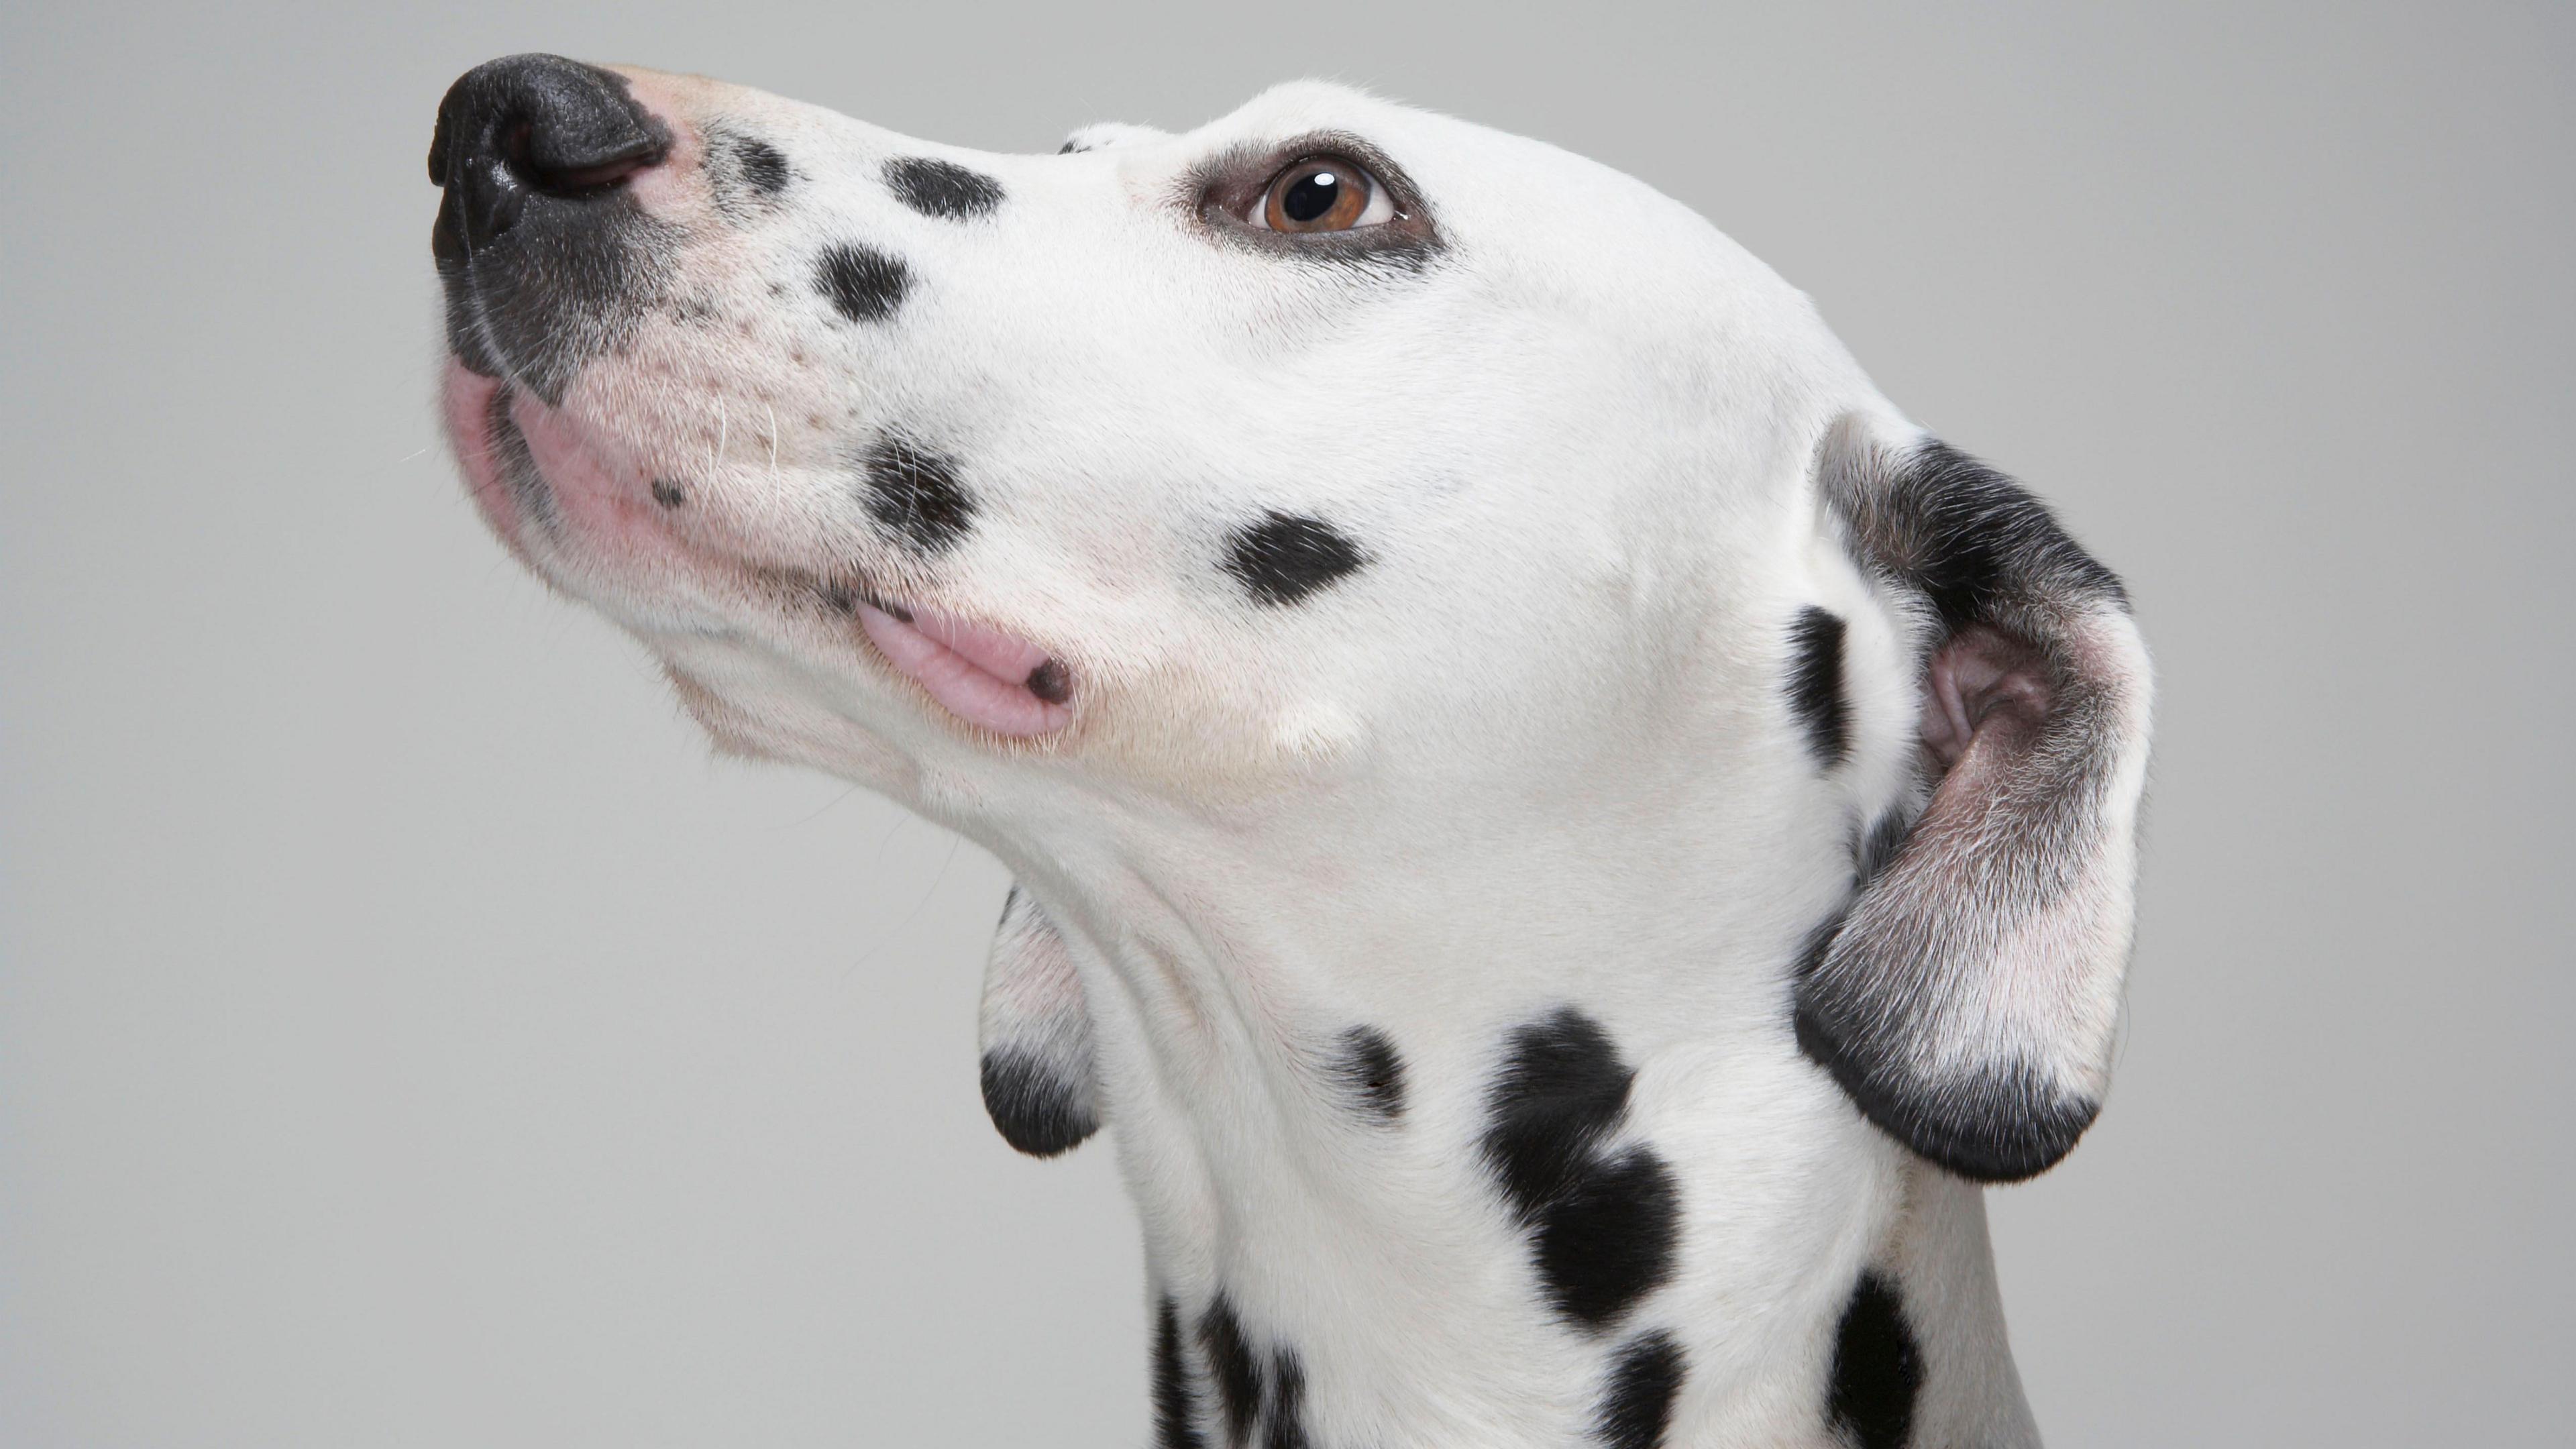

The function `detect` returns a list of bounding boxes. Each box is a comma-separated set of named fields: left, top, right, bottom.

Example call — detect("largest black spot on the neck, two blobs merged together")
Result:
left=1484, top=1008, right=1680, bottom=1328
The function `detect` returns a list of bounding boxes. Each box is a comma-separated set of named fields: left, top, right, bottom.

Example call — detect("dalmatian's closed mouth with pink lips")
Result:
left=443, top=358, right=1074, bottom=740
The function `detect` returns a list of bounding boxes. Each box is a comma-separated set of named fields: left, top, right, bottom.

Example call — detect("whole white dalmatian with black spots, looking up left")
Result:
left=430, top=57, right=2151, bottom=1449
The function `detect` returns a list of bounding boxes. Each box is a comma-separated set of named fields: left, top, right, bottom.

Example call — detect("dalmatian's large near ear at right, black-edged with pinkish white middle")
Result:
left=1795, top=415, right=2151, bottom=1181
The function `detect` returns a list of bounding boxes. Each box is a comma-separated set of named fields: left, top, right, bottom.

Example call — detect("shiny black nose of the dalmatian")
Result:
left=430, top=54, right=669, bottom=253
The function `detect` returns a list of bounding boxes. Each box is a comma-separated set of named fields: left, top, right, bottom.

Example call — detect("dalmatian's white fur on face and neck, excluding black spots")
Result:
left=443, top=72, right=2143, bottom=1449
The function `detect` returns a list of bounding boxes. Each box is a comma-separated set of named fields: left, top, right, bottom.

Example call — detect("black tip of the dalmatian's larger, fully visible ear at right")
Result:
left=1795, top=996, right=2102, bottom=1183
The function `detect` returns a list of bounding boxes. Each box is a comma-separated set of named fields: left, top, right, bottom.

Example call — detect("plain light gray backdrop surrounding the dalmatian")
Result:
left=0, top=0, right=2576, bottom=1446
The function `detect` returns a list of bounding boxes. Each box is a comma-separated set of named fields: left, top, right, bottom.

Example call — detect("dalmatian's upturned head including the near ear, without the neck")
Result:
left=430, top=57, right=2146, bottom=1176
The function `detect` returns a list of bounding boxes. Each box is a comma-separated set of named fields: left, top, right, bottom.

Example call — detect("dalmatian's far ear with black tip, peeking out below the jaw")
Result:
left=981, top=887, right=1100, bottom=1158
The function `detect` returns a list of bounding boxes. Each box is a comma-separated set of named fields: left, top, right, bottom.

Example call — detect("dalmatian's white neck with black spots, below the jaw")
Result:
left=963, top=747, right=2027, bottom=1446
